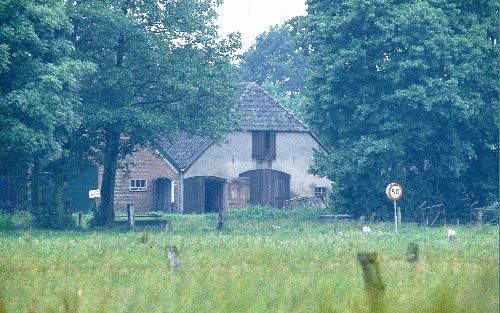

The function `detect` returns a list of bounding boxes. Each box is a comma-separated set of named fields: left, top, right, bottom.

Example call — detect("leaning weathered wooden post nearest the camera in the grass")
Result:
left=358, top=252, right=385, bottom=313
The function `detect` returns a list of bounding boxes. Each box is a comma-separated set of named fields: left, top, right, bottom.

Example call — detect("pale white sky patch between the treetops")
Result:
left=217, top=0, right=306, bottom=51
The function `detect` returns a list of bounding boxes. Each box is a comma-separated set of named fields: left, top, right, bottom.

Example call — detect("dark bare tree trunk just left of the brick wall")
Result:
left=96, top=128, right=120, bottom=227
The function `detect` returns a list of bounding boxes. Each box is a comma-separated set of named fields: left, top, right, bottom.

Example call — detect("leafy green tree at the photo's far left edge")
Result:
left=0, top=0, right=93, bottom=226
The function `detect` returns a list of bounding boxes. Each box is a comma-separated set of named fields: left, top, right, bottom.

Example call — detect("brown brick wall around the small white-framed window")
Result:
left=99, top=148, right=178, bottom=212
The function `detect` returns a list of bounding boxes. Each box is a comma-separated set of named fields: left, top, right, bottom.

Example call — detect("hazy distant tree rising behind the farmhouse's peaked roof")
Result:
left=240, top=23, right=307, bottom=117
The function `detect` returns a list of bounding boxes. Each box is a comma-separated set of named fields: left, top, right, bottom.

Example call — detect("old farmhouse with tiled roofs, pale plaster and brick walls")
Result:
left=103, top=83, right=331, bottom=213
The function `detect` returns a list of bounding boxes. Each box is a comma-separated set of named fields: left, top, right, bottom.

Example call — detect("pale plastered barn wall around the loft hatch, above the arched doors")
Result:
left=185, top=132, right=330, bottom=198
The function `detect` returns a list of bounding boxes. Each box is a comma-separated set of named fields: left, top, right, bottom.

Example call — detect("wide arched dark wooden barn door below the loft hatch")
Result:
left=240, top=169, right=290, bottom=208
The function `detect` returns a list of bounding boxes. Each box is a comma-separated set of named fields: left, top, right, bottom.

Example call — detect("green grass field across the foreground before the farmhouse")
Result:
left=0, top=208, right=499, bottom=313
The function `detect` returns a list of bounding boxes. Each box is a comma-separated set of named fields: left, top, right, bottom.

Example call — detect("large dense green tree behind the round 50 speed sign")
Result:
left=294, top=0, right=499, bottom=216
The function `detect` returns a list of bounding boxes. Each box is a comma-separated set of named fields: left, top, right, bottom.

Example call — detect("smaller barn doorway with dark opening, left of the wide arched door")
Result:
left=184, top=176, right=225, bottom=213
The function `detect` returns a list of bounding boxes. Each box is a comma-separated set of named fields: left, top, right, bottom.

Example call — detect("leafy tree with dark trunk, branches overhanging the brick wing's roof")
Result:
left=67, top=0, right=239, bottom=226
